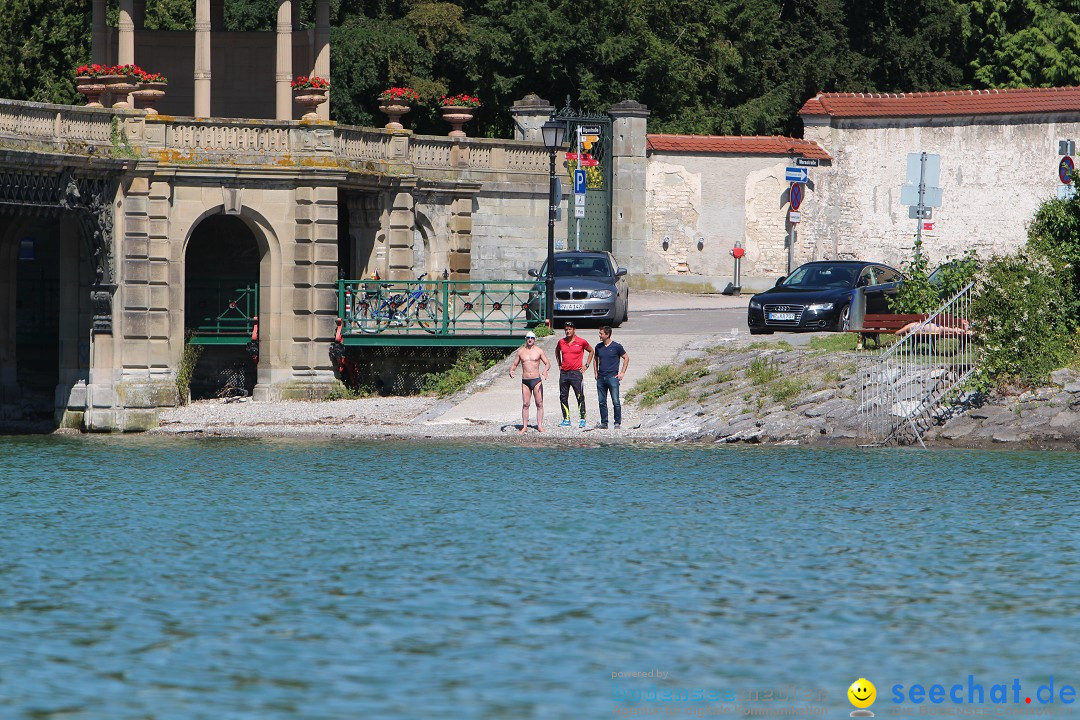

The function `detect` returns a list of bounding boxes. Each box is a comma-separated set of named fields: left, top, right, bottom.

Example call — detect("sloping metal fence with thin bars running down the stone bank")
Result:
left=855, top=284, right=977, bottom=447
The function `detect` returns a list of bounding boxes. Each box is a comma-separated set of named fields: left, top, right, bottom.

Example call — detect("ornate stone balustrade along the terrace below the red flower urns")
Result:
left=0, top=99, right=548, bottom=181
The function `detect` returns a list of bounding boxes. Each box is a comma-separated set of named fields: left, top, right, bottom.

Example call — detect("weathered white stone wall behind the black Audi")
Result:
left=798, top=116, right=1080, bottom=273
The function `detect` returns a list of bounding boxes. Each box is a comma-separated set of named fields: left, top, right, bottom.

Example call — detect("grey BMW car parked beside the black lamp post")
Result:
left=529, top=250, right=630, bottom=327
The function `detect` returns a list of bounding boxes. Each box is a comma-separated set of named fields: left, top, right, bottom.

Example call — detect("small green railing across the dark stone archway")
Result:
left=187, top=280, right=259, bottom=345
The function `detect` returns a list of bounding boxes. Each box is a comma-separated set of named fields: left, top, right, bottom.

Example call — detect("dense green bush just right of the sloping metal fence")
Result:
left=971, top=252, right=1075, bottom=385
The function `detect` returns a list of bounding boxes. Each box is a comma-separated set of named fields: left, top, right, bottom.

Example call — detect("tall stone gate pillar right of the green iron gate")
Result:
left=608, top=100, right=649, bottom=274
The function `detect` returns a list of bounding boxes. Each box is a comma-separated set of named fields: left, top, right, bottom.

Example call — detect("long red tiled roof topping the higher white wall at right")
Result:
left=799, top=87, right=1080, bottom=118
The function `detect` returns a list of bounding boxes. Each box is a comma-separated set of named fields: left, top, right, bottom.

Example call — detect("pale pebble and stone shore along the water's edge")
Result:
left=151, top=337, right=1080, bottom=449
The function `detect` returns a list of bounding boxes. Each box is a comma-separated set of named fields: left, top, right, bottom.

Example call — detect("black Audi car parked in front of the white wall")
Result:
left=746, top=260, right=901, bottom=335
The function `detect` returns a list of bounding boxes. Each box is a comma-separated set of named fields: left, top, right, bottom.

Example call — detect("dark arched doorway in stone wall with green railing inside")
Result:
left=181, top=215, right=262, bottom=399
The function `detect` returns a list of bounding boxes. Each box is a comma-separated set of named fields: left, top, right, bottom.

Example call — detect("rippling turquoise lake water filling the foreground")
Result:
left=0, top=437, right=1080, bottom=720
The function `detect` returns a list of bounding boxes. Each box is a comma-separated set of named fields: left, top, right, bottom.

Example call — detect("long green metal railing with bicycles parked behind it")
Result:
left=338, top=280, right=546, bottom=344
